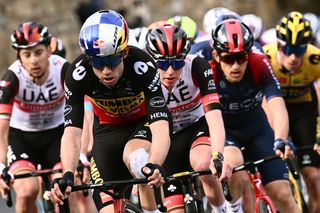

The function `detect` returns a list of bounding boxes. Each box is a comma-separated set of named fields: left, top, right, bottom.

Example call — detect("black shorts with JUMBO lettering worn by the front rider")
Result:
left=91, top=119, right=152, bottom=211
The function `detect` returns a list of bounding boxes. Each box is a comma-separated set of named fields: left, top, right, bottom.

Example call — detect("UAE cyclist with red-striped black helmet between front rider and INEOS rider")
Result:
left=147, top=24, right=231, bottom=212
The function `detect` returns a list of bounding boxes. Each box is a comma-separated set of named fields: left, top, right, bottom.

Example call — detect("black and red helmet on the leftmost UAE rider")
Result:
left=11, top=22, right=51, bottom=50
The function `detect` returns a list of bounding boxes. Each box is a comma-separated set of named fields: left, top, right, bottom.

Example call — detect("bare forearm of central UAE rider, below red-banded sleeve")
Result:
left=206, top=110, right=226, bottom=153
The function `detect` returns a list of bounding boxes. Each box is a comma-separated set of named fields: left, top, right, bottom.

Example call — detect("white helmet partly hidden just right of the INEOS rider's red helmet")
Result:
left=242, top=13, right=263, bottom=40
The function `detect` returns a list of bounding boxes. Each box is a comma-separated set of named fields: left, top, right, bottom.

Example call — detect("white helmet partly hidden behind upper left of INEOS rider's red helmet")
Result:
left=202, top=7, right=231, bottom=34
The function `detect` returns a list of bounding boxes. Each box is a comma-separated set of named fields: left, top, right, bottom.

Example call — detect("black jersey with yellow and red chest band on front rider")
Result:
left=65, top=46, right=170, bottom=128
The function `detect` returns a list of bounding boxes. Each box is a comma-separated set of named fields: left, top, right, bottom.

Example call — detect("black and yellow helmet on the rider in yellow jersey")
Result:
left=276, top=11, right=312, bottom=46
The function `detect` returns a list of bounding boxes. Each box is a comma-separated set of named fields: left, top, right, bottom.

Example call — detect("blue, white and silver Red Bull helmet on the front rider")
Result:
left=79, top=10, right=128, bottom=57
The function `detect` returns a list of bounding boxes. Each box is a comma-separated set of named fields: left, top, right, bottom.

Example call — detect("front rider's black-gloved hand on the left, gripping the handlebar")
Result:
left=49, top=171, right=74, bottom=205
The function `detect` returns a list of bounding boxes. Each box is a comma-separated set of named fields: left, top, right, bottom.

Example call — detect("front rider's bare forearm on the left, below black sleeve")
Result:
left=61, top=127, right=82, bottom=172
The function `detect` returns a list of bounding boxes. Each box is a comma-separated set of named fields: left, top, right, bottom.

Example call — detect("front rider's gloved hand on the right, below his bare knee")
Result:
left=141, top=163, right=166, bottom=188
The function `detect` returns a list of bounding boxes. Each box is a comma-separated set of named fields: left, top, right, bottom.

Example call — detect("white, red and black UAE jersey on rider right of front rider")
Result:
left=162, top=55, right=220, bottom=132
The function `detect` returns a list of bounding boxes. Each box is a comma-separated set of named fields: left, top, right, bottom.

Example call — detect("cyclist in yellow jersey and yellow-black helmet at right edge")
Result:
left=263, top=11, right=320, bottom=212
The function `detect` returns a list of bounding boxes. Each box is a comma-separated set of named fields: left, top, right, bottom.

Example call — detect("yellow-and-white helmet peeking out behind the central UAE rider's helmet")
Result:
left=167, top=16, right=198, bottom=41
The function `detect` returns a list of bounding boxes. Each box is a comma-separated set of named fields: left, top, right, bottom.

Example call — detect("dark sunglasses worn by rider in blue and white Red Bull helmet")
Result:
left=89, top=54, right=123, bottom=69
